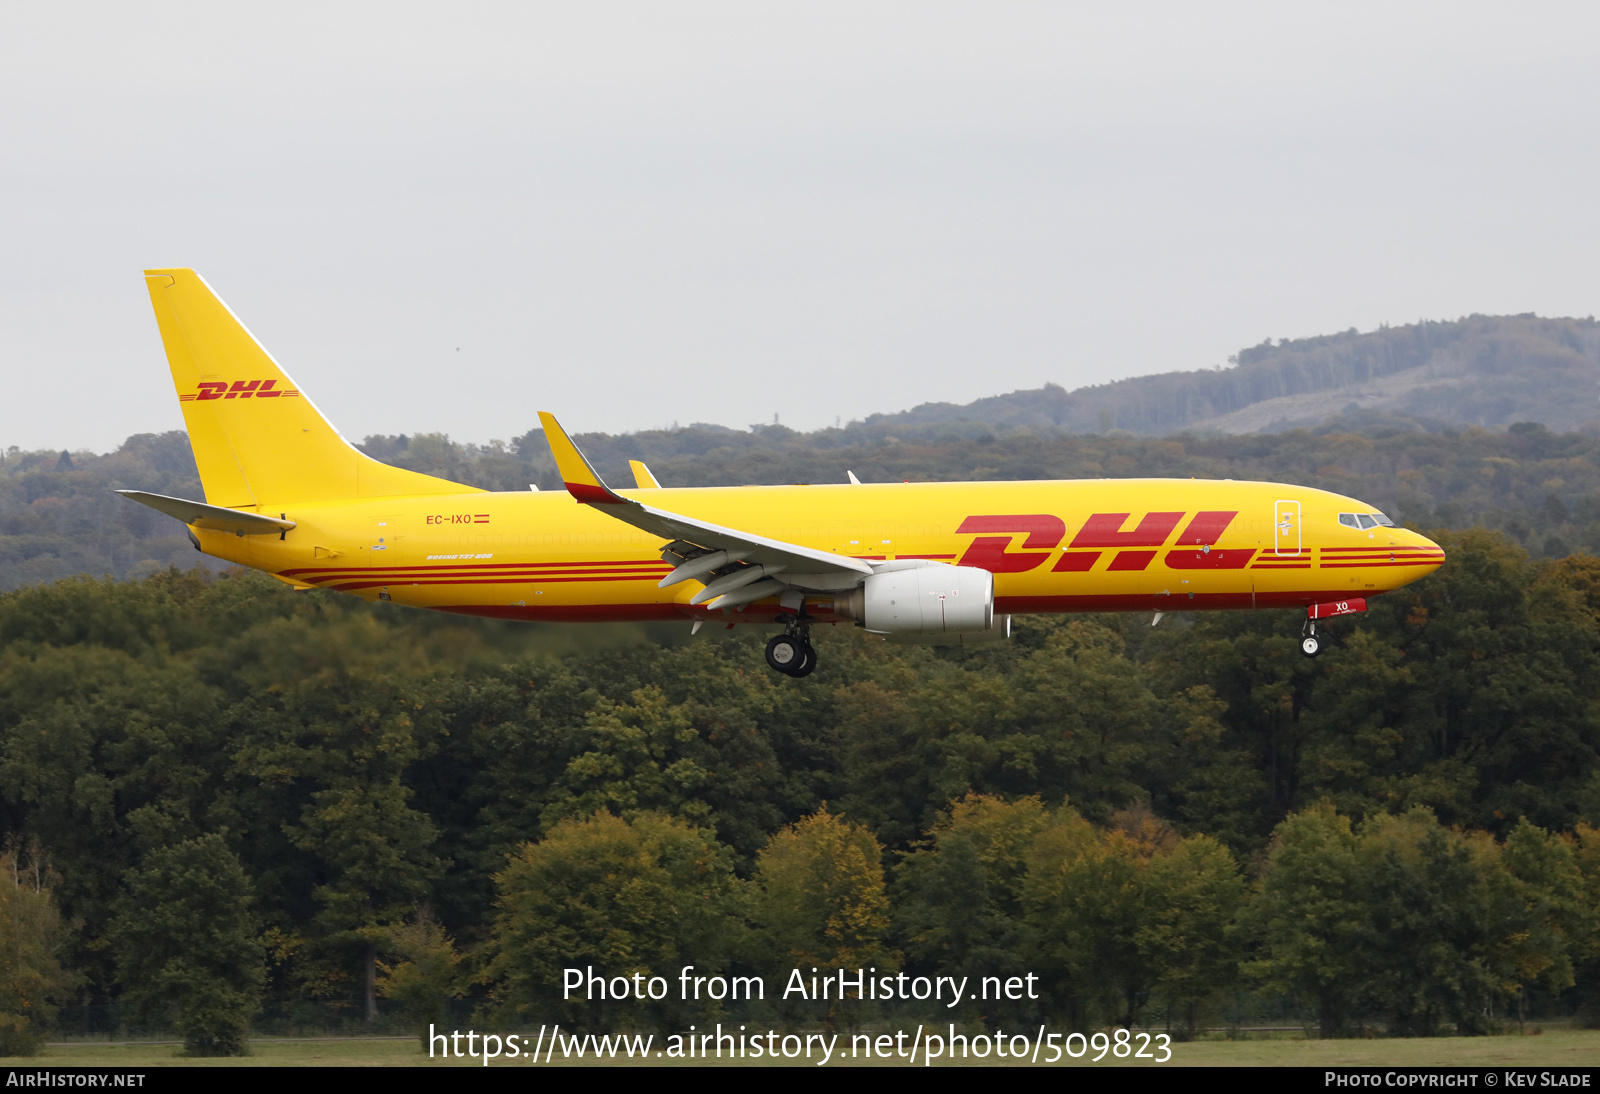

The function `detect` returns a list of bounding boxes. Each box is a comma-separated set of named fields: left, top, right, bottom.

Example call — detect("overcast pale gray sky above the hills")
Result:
left=0, top=0, right=1600, bottom=451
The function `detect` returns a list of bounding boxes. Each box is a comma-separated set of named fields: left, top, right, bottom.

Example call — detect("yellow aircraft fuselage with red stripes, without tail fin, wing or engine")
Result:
left=197, top=478, right=1445, bottom=622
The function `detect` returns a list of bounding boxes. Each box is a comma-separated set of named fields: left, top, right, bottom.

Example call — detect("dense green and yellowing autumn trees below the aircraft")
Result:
left=0, top=531, right=1600, bottom=1051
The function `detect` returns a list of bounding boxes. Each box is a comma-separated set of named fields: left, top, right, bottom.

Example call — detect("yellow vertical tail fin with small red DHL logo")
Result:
left=144, top=269, right=475, bottom=509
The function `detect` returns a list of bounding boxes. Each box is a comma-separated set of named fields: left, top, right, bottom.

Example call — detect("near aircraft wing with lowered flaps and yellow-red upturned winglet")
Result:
left=539, top=411, right=872, bottom=606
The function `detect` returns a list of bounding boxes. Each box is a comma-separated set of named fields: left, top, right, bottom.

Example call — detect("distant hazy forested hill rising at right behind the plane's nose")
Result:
left=866, top=315, right=1600, bottom=435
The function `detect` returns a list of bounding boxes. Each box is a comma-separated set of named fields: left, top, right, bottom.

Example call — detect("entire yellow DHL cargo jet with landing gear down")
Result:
left=120, top=270, right=1445, bottom=677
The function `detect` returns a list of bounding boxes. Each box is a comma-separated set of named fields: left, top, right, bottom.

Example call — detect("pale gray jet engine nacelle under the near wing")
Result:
left=834, top=560, right=1011, bottom=641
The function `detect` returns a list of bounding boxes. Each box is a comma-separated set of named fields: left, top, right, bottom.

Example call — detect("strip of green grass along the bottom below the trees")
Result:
left=0, top=1028, right=1600, bottom=1068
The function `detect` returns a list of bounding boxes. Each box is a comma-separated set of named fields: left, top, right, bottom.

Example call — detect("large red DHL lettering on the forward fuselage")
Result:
left=955, top=510, right=1256, bottom=574
